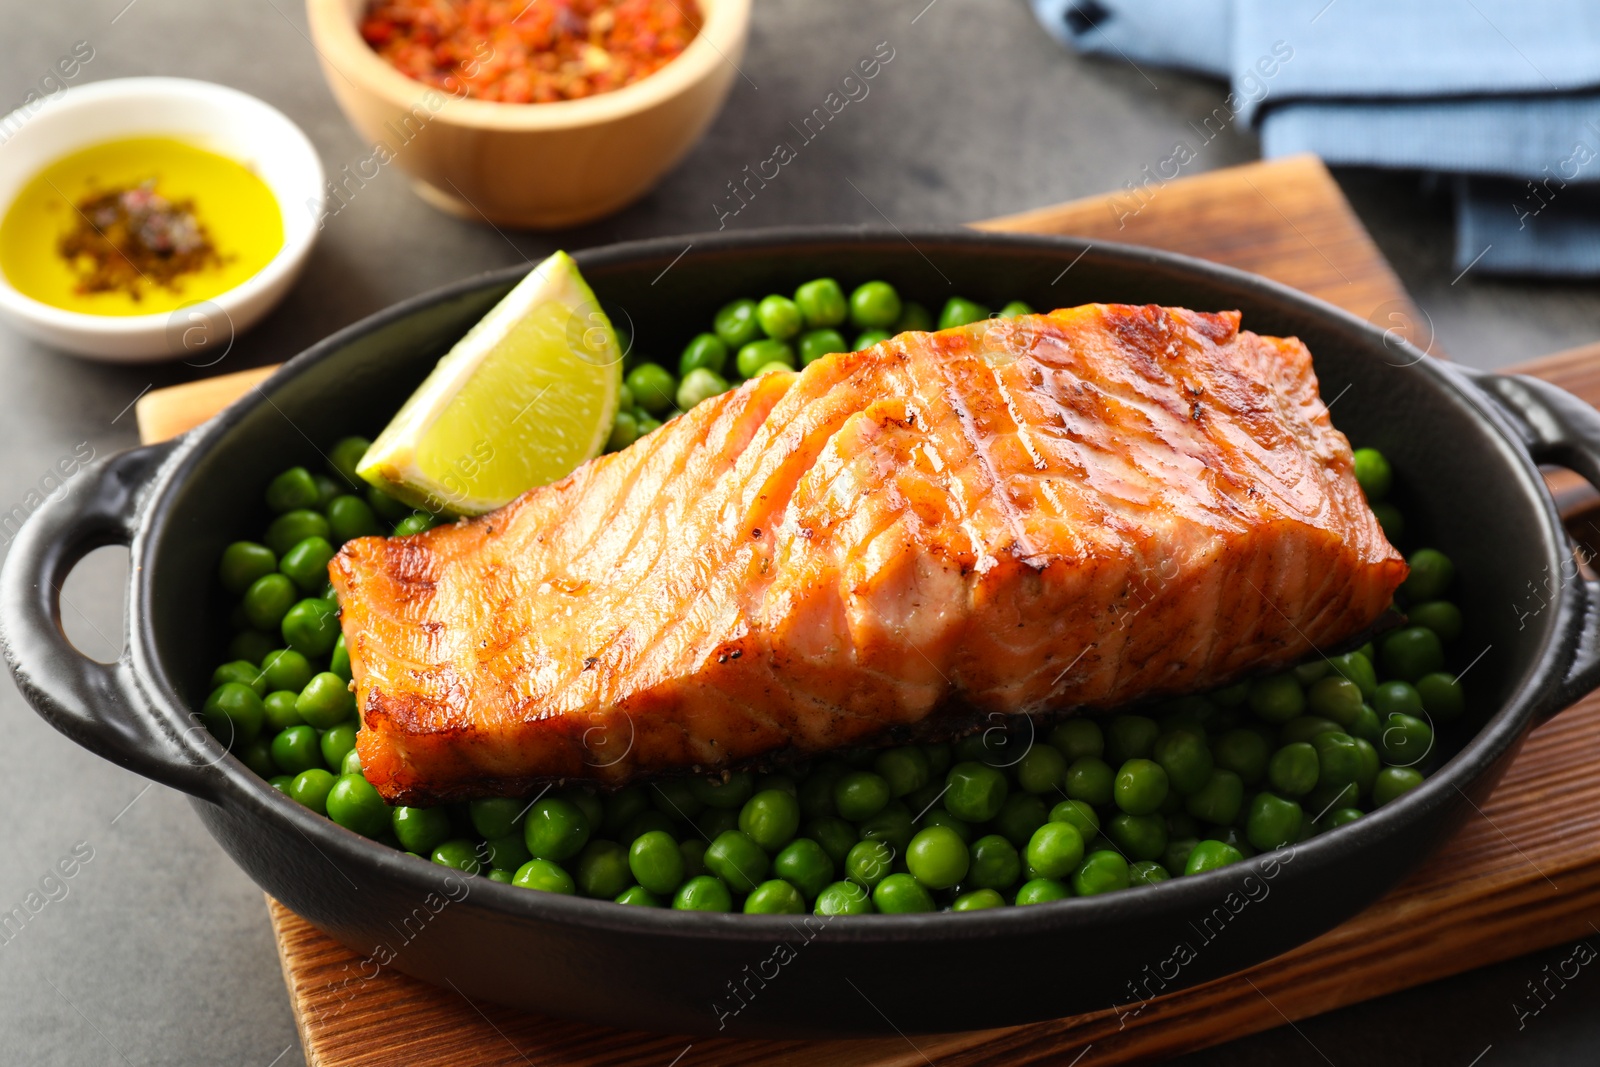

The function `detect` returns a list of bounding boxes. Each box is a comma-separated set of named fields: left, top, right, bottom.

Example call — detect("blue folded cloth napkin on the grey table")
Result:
left=1030, top=0, right=1600, bottom=277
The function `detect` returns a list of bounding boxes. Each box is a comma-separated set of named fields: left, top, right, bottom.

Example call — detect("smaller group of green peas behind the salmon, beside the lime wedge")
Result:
left=606, top=278, right=1034, bottom=451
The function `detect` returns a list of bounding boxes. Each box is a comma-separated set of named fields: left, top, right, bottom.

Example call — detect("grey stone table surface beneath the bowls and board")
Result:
left=0, top=0, right=1600, bottom=1067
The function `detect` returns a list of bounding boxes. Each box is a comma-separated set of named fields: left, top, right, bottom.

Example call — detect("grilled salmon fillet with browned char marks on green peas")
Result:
left=330, top=304, right=1406, bottom=803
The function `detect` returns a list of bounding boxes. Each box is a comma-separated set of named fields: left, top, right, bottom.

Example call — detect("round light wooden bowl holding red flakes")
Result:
left=306, top=0, right=750, bottom=229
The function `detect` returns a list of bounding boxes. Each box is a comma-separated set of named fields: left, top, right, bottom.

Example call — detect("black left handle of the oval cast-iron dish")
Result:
left=0, top=442, right=221, bottom=800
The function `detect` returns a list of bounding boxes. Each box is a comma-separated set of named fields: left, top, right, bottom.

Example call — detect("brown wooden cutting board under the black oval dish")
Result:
left=138, top=157, right=1600, bottom=1067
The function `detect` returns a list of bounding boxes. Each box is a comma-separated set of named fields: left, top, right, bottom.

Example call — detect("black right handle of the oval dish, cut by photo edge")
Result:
left=1462, top=371, right=1600, bottom=718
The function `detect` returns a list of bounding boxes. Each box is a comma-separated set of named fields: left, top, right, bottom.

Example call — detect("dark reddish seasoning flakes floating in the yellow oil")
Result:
left=58, top=179, right=222, bottom=301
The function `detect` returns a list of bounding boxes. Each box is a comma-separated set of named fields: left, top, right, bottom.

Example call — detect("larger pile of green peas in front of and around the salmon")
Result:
left=202, top=438, right=1466, bottom=915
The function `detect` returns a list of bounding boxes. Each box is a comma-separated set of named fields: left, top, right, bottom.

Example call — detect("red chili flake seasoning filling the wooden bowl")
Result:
left=362, top=0, right=701, bottom=104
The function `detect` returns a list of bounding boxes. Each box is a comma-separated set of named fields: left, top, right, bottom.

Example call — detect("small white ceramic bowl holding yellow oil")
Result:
left=0, top=78, right=323, bottom=362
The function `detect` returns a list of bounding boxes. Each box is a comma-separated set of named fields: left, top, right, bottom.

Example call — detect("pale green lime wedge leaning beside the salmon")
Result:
left=355, top=251, right=622, bottom=515
